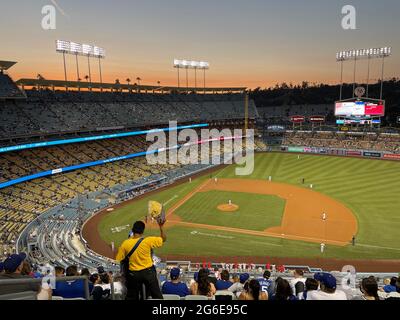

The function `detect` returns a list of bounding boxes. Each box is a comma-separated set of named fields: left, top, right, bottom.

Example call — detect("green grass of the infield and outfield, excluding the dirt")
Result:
left=98, top=153, right=400, bottom=259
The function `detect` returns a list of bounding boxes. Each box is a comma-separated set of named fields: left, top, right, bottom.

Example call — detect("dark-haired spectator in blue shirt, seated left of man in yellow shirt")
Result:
left=53, top=266, right=86, bottom=299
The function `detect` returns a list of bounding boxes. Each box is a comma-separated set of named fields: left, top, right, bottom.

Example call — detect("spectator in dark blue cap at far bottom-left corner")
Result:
left=0, top=252, right=51, bottom=300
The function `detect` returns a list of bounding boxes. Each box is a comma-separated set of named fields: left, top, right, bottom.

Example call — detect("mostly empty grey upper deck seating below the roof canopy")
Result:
left=0, top=91, right=256, bottom=139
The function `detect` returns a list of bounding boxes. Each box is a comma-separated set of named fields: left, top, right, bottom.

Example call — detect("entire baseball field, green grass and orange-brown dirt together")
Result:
left=83, top=153, right=400, bottom=268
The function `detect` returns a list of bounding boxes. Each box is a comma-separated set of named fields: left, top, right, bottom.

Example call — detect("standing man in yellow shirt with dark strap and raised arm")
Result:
left=116, top=221, right=167, bottom=300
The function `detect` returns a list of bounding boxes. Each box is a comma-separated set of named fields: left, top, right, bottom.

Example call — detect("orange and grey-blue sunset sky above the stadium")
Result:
left=0, top=0, right=400, bottom=88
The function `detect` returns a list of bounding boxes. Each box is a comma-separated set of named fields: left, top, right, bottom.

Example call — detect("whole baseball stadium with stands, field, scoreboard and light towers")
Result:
left=0, top=0, right=400, bottom=300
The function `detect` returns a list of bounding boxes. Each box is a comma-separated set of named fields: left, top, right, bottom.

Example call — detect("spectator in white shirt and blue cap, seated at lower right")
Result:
left=307, top=272, right=347, bottom=300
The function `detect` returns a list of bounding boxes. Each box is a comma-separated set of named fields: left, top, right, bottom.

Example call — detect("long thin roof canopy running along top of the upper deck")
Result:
left=16, top=79, right=246, bottom=93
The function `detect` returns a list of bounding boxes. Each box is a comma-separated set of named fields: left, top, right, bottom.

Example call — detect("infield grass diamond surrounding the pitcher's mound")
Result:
left=175, top=190, right=286, bottom=231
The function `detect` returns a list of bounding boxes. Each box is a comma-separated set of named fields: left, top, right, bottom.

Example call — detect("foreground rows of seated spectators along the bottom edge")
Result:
left=0, top=253, right=400, bottom=301
